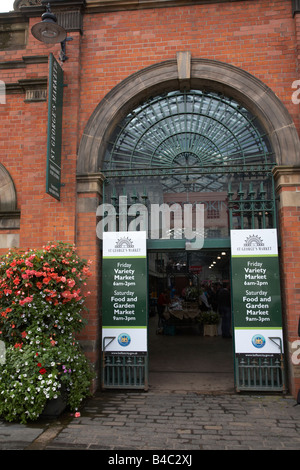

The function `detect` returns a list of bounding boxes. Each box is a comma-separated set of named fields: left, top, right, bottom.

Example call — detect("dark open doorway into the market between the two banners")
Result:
left=148, top=250, right=234, bottom=393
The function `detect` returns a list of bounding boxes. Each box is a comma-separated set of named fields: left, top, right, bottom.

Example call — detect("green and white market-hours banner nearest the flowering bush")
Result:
left=102, top=232, right=148, bottom=354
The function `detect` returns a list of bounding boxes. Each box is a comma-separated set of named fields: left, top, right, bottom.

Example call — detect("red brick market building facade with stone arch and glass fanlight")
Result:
left=0, top=0, right=300, bottom=395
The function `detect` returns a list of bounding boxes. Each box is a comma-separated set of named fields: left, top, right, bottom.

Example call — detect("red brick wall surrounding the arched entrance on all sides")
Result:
left=0, top=0, right=300, bottom=396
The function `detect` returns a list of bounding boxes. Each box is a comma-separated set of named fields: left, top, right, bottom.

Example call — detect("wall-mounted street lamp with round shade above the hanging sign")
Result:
left=31, top=3, right=71, bottom=62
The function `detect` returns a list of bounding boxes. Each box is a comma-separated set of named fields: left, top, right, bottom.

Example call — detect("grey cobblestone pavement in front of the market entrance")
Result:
left=0, top=391, right=300, bottom=451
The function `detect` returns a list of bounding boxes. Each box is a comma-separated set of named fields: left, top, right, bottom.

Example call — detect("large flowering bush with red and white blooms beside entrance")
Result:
left=0, top=242, right=93, bottom=423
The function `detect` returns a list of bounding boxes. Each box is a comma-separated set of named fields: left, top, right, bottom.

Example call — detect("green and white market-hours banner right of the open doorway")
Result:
left=231, top=229, right=283, bottom=356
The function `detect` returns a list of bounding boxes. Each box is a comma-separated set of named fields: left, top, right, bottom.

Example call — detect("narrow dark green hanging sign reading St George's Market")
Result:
left=46, top=54, right=64, bottom=200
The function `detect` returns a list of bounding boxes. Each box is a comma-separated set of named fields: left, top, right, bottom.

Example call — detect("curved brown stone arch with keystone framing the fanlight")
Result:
left=77, top=57, right=300, bottom=175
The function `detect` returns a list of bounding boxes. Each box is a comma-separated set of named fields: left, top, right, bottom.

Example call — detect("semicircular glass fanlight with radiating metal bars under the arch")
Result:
left=103, top=90, right=273, bottom=192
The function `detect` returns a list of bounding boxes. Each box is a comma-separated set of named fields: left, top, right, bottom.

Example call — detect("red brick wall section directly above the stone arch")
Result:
left=78, top=0, right=299, bottom=139
